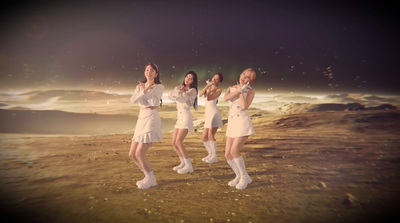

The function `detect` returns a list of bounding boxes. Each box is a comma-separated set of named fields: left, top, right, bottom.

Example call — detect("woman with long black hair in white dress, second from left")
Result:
left=168, top=71, right=197, bottom=174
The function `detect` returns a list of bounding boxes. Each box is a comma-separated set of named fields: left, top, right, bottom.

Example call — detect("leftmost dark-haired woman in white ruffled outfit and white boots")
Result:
left=129, top=63, right=164, bottom=189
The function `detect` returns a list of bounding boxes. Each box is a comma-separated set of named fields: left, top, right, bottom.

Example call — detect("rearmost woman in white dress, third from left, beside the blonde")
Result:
left=199, top=73, right=224, bottom=163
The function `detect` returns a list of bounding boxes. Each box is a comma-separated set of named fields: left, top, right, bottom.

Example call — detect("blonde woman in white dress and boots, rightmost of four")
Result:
left=224, top=68, right=256, bottom=189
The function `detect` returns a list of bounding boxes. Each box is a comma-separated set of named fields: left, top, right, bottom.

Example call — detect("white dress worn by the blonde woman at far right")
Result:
left=226, top=88, right=255, bottom=138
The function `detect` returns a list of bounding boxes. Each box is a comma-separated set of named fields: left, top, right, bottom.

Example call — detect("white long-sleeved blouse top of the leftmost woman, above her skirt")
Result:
left=131, top=84, right=164, bottom=107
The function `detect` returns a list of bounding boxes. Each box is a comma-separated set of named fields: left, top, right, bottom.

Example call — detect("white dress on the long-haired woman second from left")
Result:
left=168, top=87, right=197, bottom=131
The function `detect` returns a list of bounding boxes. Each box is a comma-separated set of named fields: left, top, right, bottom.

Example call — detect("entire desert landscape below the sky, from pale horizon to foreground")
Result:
left=0, top=91, right=400, bottom=223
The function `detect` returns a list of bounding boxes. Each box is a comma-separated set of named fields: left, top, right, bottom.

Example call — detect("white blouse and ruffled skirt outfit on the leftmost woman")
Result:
left=131, top=84, right=164, bottom=143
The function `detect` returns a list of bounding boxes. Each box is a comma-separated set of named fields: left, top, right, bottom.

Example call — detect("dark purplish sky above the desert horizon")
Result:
left=0, top=0, right=400, bottom=95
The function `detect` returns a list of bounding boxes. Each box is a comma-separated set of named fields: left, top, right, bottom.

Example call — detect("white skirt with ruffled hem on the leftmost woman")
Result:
left=132, top=109, right=162, bottom=143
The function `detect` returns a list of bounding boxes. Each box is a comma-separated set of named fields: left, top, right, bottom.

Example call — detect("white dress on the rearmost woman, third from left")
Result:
left=204, top=98, right=224, bottom=129
